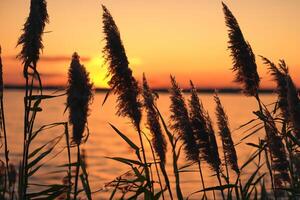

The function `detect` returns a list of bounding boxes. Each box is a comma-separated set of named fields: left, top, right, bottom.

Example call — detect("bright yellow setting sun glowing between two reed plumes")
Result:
left=87, top=56, right=109, bottom=88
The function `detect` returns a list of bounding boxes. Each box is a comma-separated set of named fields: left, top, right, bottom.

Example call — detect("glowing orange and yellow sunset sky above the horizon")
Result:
left=0, top=0, right=300, bottom=88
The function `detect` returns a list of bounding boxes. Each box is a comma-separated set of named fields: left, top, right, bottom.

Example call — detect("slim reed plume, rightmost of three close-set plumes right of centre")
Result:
left=214, top=93, right=240, bottom=174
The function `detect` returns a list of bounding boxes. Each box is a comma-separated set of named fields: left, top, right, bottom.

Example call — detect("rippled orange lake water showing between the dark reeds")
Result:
left=1, top=90, right=275, bottom=199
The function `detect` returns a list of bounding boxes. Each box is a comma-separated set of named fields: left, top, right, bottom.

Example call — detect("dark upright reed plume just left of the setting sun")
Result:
left=67, top=53, right=93, bottom=145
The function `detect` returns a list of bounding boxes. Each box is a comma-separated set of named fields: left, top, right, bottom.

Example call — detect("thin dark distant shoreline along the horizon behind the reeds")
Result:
left=4, top=85, right=274, bottom=94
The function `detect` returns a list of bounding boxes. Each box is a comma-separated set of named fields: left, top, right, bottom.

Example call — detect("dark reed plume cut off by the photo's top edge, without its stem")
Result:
left=17, top=0, right=49, bottom=73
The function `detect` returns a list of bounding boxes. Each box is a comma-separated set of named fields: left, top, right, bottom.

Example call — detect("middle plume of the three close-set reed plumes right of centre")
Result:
left=189, top=81, right=210, bottom=161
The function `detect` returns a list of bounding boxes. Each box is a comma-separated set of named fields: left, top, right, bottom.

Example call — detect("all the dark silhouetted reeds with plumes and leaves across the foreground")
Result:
left=0, top=0, right=300, bottom=200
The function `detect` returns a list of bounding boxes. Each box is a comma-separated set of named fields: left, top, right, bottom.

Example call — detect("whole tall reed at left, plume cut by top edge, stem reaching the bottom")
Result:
left=17, top=0, right=49, bottom=199
